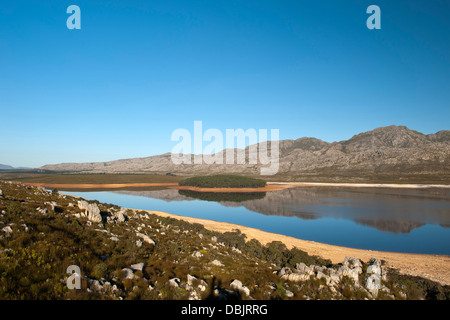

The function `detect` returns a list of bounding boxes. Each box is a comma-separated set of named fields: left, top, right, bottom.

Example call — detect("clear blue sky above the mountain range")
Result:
left=0, top=0, right=450, bottom=167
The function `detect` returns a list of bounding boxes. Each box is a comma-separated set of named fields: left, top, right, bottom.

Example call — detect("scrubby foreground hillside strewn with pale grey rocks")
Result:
left=0, top=181, right=450, bottom=300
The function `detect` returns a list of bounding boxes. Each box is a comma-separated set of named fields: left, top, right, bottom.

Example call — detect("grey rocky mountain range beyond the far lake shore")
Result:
left=40, top=125, right=450, bottom=183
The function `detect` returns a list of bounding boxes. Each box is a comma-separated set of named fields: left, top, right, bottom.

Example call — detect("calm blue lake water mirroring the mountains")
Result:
left=66, top=188, right=450, bottom=255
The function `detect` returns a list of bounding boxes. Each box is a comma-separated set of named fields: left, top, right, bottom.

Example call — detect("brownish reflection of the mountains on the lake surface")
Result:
left=117, top=187, right=450, bottom=234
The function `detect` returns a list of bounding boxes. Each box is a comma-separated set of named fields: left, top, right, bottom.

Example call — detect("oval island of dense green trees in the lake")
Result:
left=179, top=175, right=266, bottom=188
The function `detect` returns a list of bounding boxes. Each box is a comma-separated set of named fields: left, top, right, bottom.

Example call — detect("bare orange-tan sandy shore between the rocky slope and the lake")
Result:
left=138, top=210, right=450, bottom=285
